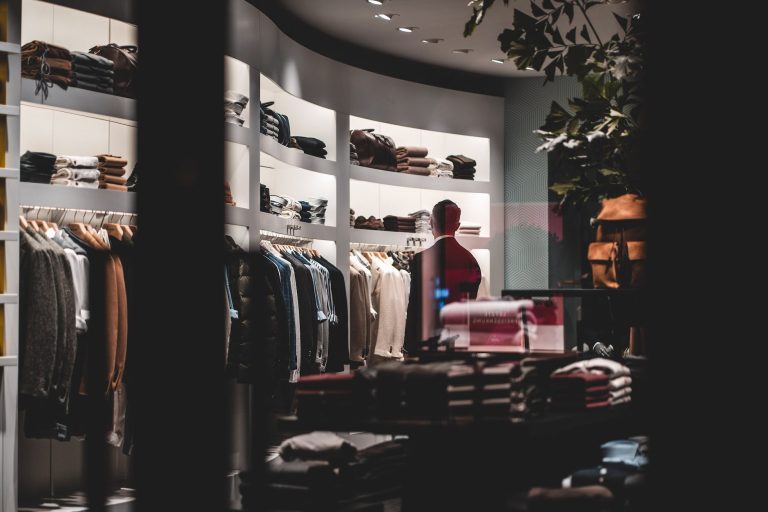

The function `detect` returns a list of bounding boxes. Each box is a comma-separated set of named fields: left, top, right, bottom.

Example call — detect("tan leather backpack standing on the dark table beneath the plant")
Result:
left=587, top=194, right=647, bottom=288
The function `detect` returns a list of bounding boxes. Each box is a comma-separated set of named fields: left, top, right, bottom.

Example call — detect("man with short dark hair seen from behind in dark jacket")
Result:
left=405, top=199, right=481, bottom=353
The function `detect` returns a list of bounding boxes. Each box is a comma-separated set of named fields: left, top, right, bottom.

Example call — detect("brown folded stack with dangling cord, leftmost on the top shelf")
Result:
left=21, top=41, right=72, bottom=91
